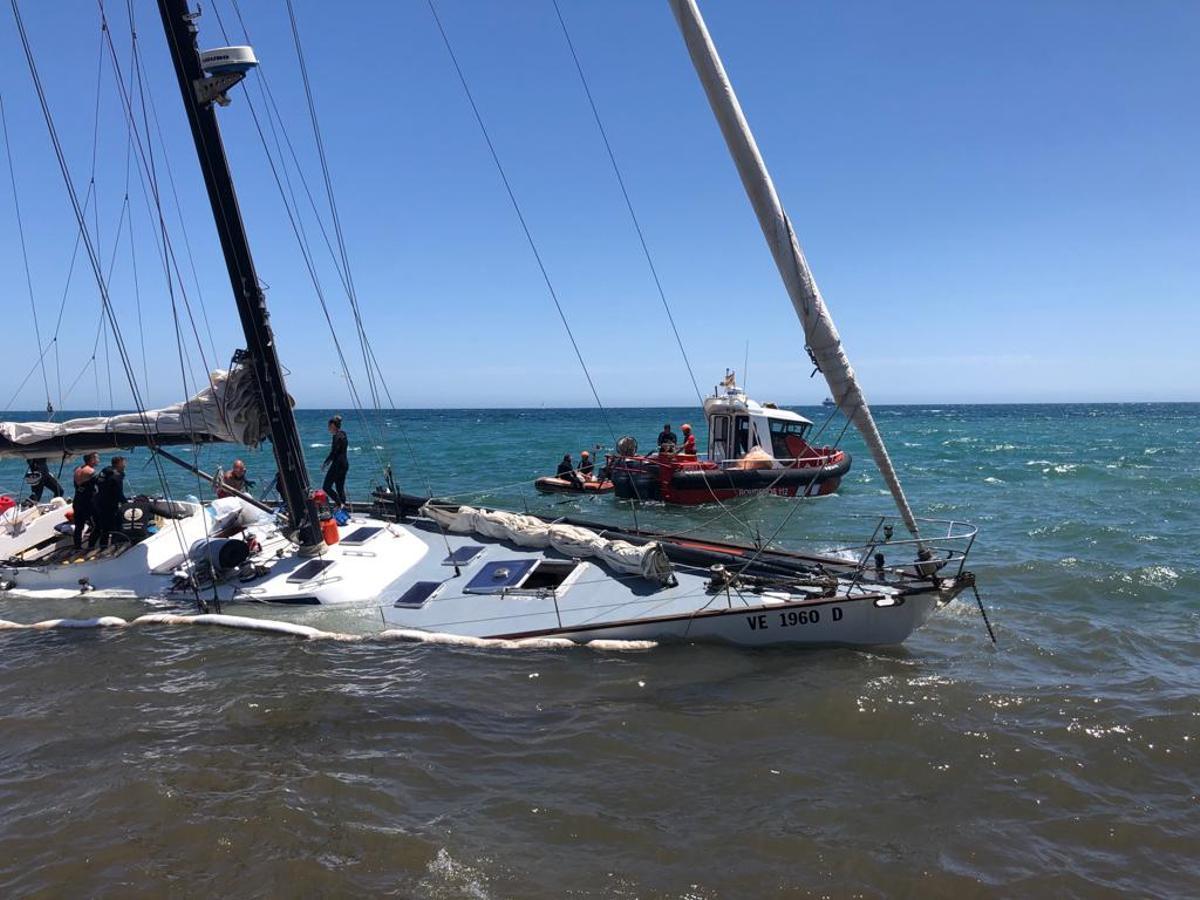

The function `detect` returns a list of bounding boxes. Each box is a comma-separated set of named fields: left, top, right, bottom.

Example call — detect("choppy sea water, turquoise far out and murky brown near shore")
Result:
left=0, top=404, right=1200, bottom=898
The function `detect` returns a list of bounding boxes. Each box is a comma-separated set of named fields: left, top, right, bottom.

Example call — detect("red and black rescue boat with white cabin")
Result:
left=608, top=372, right=851, bottom=505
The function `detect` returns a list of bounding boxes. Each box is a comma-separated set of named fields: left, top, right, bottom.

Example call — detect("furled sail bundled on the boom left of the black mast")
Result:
left=0, top=365, right=270, bottom=458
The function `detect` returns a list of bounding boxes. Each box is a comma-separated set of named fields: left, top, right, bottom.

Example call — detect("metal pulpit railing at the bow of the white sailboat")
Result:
left=828, top=512, right=979, bottom=583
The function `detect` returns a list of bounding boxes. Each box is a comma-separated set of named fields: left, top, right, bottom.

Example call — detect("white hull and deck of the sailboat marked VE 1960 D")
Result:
left=0, top=504, right=961, bottom=647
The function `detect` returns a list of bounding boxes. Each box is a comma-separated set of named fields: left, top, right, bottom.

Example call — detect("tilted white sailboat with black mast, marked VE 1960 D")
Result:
left=0, top=0, right=974, bottom=647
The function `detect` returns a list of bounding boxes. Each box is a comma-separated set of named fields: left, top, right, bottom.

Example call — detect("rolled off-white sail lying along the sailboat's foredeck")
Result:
left=421, top=503, right=673, bottom=584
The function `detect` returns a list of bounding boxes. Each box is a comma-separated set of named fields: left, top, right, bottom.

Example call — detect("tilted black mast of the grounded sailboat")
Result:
left=158, top=0, right=322, bottom=547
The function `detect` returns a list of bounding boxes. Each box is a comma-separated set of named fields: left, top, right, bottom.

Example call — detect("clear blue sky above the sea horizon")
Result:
left=0, top=0, right=1200, bottom=408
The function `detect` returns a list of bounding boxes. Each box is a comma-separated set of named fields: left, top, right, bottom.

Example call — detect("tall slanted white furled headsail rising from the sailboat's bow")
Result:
left=670, top=0, right=920, bottom=538
